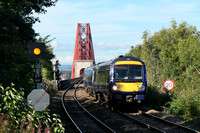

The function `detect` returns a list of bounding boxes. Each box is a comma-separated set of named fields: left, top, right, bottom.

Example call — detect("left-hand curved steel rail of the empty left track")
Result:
left=61, top=79, right=82, bottom=133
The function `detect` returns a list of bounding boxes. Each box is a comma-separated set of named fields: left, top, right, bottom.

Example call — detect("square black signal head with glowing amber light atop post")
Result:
left=28, top=43, right=45, bottom=60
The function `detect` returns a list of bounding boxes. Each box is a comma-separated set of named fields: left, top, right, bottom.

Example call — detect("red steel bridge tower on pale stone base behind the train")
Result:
left=71, top=23, right=95, bottom=78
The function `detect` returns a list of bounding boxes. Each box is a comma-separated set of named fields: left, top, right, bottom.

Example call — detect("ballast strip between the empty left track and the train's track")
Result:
left=74, top=87, right=151, bottom=133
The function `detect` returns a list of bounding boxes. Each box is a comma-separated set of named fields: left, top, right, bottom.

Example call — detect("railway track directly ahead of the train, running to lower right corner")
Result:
left=117, top=110, right=200, bottom=133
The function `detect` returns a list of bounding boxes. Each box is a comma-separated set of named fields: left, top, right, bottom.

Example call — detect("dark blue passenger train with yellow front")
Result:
left=83, top=56, right=147, bottom=105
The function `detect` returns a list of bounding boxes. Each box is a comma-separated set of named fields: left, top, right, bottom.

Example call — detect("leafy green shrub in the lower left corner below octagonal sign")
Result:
left=0, top=84, right=65, bottom=133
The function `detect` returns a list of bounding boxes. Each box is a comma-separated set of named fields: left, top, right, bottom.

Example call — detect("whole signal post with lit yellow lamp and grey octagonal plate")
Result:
left=27, top=43, right=50, bottom=111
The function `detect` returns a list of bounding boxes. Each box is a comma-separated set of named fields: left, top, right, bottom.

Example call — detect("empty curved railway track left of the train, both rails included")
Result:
left=61, top=80, right=115, bottom=133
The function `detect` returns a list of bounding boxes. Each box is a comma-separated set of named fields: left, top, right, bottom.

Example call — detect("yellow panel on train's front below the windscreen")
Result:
left=116, top=82, right=142, bottom=92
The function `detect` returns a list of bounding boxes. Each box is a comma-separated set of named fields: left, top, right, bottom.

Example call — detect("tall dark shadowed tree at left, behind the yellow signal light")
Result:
left=0, top=0, right=56, bottom=93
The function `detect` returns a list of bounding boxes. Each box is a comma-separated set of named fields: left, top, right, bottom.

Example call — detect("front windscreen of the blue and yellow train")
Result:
left=115, top=65, right=143, bottom=82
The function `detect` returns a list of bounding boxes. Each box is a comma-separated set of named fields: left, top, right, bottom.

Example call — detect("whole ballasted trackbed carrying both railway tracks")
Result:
left=58, top=79, right=199, bottom=133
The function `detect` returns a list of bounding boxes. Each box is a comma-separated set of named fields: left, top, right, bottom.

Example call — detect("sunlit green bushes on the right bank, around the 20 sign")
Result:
left=126, top=20, right=200, bottom=119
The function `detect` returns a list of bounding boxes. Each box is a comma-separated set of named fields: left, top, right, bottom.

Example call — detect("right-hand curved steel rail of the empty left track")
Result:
left=74, top=80, right=116, bottom=133
